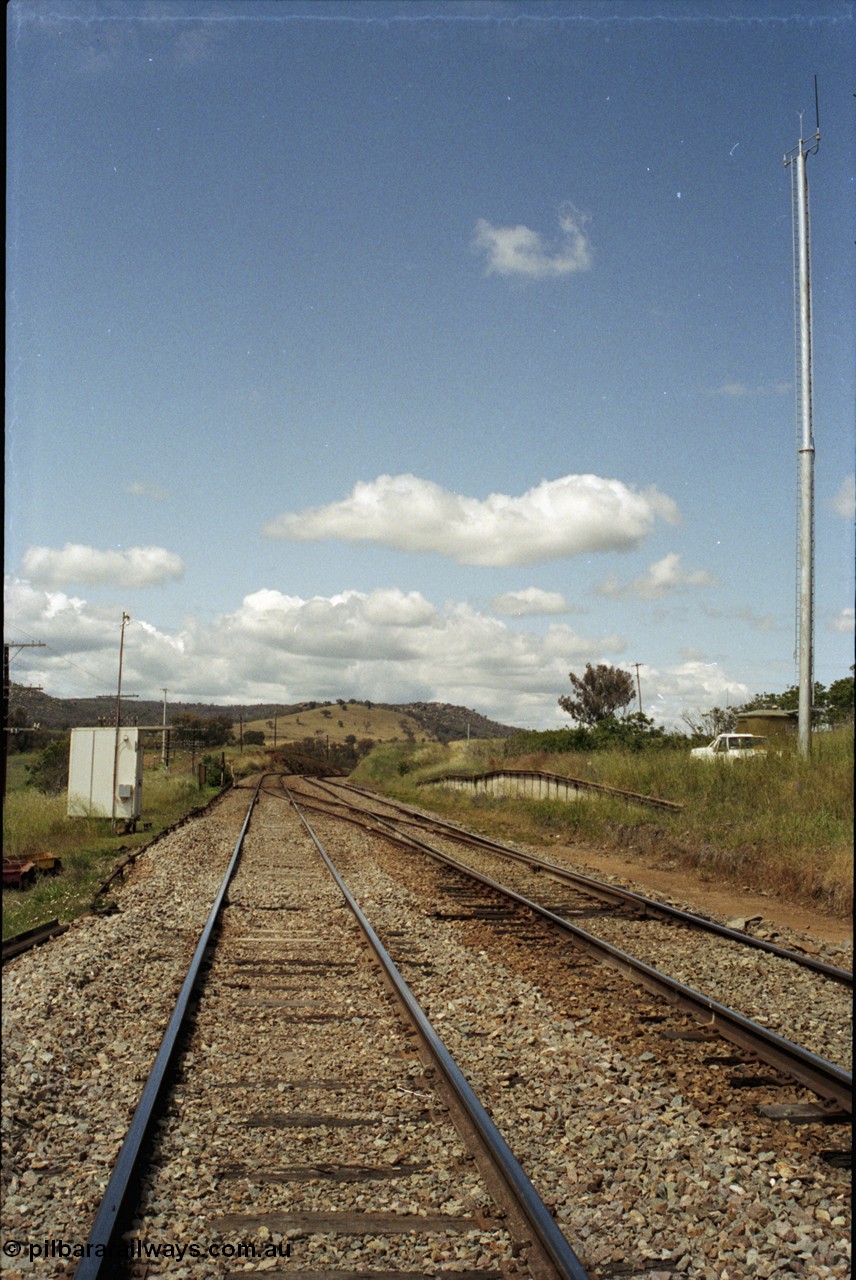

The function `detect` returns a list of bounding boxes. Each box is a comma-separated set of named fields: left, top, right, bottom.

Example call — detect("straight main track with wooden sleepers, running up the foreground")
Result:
left=77, top=787, right=589, bottom=1280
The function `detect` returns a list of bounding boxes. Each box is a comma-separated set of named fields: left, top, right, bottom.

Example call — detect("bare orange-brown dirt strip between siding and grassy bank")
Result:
left=553, top=842, right=853, bottom=948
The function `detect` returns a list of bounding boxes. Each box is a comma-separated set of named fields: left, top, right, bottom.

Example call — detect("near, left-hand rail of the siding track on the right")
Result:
left=358, top=819, right=853, bottom=1114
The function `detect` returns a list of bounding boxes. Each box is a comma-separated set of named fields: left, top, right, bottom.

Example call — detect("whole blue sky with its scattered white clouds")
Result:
left=5, top=0, right=856, bottom=727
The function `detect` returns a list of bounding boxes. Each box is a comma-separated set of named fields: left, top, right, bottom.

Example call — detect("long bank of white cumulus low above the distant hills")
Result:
left=6, top=580, right=624, bottom=724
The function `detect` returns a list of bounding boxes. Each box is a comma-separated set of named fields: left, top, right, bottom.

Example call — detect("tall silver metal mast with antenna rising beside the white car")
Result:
left=784, top=97, right=820, bottom=759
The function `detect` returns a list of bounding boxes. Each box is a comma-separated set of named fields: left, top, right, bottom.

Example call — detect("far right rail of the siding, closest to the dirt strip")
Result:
left=312, top=780, right=853, bottom=987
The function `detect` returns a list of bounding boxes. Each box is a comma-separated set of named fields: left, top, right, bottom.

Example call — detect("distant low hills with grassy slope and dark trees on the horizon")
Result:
left=9, top=685, right=516, bottom=744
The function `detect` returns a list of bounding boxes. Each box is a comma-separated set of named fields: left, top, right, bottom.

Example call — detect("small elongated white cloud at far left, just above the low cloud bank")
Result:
left=22, top=543, right=184, bottom=588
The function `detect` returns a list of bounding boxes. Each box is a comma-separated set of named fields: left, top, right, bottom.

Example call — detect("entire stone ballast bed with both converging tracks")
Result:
left=4, top=776, right=852, bottom=1280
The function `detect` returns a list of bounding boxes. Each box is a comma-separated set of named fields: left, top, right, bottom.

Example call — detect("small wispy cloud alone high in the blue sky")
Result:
left=472, top=205, right=592, bottom=280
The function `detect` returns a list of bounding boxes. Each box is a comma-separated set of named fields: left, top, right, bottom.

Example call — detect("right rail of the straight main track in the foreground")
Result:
left=283, top=783, right=589, bottom=1280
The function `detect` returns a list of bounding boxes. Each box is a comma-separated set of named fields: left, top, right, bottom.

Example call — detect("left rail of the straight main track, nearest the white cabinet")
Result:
left=74, top=780, right=264, bottom=1280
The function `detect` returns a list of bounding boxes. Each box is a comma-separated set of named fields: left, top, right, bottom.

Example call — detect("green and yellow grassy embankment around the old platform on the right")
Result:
left=353, top=728, right=853, bottom=915
